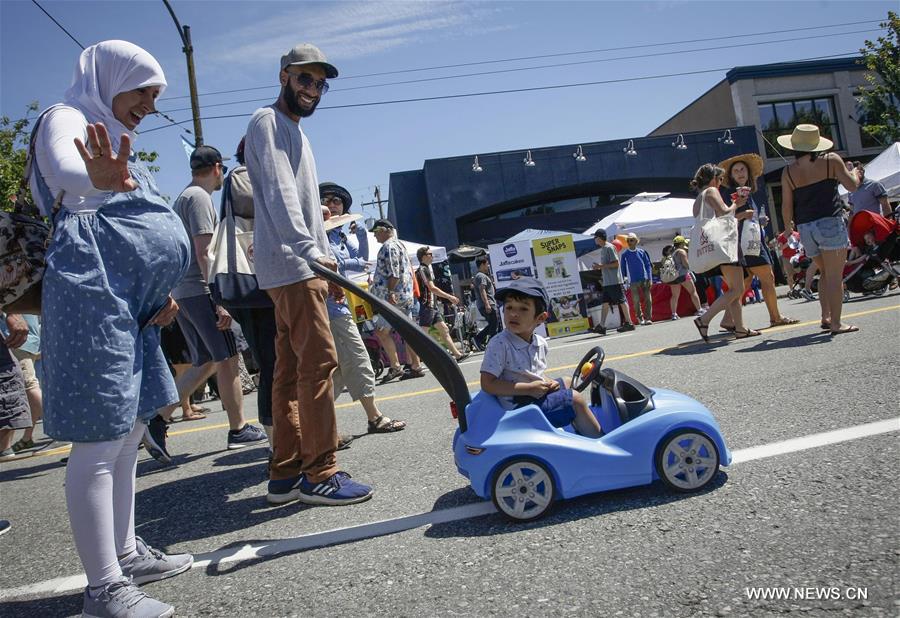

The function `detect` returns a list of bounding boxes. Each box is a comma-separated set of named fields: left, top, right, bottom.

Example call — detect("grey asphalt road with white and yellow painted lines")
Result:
left=0, top=291, right=900, bottom=617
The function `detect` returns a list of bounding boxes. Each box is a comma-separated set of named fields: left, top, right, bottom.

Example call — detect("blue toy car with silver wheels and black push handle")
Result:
left=310, top=262, right=731, bottom=520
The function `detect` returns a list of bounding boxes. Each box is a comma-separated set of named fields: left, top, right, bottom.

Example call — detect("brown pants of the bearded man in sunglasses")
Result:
left=268, top=278, right=338, bottom=483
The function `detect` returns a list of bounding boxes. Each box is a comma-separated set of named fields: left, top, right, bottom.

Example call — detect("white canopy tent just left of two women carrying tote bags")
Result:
left=584, top=193, right=694, bottom=262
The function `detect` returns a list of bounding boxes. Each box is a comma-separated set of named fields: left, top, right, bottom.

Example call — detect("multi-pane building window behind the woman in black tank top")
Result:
left=758, top=97, right=844, bottom=158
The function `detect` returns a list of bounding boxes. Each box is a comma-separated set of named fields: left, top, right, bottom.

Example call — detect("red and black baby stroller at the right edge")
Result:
left=844, top=210, right=900, bottom=296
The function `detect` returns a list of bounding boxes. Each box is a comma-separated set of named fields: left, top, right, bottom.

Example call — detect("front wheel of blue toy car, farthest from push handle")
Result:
left=656, top=429, right=719, bottom=492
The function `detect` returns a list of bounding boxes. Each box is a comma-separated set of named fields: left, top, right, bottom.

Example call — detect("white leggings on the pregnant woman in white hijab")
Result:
left=66, top=422, right=144, bottom=587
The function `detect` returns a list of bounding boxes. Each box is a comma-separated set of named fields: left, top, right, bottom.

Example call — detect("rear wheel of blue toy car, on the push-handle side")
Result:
left=491, top=458, right=556, bottom=521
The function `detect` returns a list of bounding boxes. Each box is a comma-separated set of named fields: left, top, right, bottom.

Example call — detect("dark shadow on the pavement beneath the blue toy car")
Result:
left=425, top=470, right=728, bottom=539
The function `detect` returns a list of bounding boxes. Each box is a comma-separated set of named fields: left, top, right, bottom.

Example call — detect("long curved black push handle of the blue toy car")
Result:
left=308, top=261, right=471, bottom=432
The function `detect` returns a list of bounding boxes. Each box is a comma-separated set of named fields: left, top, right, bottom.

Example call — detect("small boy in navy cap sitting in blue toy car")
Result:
left=481, top=277, right=603, bottom=438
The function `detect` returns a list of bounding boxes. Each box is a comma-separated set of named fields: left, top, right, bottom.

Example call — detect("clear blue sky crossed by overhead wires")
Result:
left=0, top=0, right=897, bottom=229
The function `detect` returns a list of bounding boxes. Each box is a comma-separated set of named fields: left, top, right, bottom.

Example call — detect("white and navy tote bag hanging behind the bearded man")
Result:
left=207, top=173, right=273, bottom=309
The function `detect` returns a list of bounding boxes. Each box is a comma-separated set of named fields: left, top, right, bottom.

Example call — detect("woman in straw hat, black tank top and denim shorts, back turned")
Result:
left=778, top=124, right=859, bottom=335
